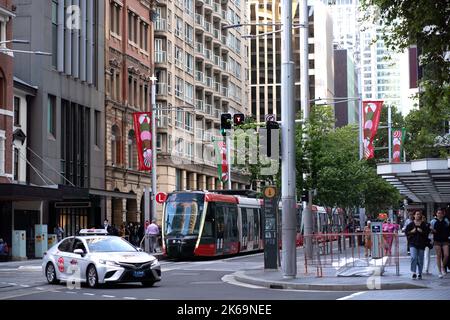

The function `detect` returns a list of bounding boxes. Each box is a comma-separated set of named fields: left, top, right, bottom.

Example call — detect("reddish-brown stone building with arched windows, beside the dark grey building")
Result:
left=102, top=0, right=154, bottom=228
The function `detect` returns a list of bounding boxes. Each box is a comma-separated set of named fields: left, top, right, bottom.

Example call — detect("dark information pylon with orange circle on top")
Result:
left=263, top=186, right=278, bottom=270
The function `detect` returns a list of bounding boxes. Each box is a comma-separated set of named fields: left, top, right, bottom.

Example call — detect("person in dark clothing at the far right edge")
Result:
left=431, top=209, right=450, bottom=278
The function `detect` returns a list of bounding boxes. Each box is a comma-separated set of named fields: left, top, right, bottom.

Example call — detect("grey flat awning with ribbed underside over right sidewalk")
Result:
left=377, top=158, right=450, bottom=203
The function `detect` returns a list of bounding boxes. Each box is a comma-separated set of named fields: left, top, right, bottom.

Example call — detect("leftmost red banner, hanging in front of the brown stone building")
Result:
left=133, top=112, right=152, bottom=171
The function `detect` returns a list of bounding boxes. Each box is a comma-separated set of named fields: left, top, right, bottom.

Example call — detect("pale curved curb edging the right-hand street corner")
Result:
left=232, top=272, right=428, bottom=291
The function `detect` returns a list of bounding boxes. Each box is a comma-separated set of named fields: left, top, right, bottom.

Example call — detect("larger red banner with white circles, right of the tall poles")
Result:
left=363, top=100, right=383, bottom=159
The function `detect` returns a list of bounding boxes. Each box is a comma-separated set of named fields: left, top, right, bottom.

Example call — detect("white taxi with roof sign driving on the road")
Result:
left=42, top=229, right=161, bottom=288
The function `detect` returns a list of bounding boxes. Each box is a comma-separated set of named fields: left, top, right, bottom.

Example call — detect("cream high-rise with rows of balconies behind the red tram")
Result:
left=154, top=0, right=249, bottom=215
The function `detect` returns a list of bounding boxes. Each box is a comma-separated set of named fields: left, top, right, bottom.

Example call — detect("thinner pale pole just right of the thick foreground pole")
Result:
left=300, top=0, right=313, bottom=259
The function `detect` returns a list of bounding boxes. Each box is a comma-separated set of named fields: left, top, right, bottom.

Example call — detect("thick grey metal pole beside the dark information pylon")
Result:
left=281, top=0, right=298, bottom=278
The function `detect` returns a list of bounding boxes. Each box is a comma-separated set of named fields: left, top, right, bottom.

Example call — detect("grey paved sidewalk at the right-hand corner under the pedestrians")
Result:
left=233, top=236, right=450, bottom=291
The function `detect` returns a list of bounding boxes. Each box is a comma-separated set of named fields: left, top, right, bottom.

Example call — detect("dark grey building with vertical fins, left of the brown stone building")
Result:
left=11, top=0, right=106, bottom=251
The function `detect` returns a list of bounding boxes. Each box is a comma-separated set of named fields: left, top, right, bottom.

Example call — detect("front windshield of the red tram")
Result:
left=164, top=193, right=205, bottom=236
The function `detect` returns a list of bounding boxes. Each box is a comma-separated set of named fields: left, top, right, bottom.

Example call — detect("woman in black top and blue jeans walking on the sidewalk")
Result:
left=405, top=210, right=430, bottom=280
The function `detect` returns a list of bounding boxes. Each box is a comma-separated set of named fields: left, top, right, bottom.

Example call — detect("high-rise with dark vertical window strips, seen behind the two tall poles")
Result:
left=247, top=0, right=334, bottom=121
